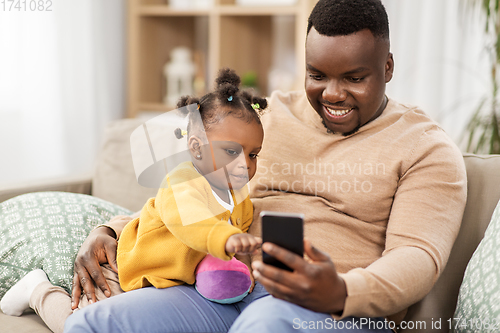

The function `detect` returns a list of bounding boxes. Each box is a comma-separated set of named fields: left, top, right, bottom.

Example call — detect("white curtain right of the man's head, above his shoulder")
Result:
left=382, top=0, right=490, bottom=145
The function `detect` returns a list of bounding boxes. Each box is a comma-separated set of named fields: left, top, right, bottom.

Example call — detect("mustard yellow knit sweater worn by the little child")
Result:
left=117, top=162, right=253, bottom=291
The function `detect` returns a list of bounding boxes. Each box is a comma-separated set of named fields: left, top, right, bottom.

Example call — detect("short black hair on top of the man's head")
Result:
left=307, top=0, right=389, bottom=40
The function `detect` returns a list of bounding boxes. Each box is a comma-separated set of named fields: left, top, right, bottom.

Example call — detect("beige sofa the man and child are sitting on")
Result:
left=0, top=119, right=500, bottom=333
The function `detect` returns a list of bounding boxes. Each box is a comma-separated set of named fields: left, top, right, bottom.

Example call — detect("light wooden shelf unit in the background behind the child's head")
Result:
left=127, top=0, right=317, bottom=117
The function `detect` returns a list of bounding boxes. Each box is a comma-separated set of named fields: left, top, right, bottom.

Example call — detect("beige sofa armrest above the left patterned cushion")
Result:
left=0, top=174, right=92, bottom=202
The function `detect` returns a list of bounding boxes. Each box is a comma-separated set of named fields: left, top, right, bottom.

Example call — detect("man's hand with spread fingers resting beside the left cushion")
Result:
left=71, top=227, right=118, bottom=310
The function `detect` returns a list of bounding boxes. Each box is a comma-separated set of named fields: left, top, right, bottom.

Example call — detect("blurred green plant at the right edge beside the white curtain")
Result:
left=465, top=0, right=500, bottom=154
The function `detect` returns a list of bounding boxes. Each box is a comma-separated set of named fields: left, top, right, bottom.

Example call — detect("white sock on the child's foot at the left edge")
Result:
left=0, top=269, right=49, bottom=317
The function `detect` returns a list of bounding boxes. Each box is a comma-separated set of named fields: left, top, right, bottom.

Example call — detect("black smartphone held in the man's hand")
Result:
left=260, top=211, right=304, bottom=271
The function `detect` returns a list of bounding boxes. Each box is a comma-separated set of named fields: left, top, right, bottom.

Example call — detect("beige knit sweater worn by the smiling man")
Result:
left=251, top=92, right=467, bottom=320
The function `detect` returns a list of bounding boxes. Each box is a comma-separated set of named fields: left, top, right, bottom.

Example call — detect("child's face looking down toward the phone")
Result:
left=194, top=116, right=264, bottom=190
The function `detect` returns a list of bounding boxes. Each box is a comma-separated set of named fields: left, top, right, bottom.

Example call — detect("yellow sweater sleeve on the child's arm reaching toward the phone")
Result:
left=156, top=176, right=241, bottom=260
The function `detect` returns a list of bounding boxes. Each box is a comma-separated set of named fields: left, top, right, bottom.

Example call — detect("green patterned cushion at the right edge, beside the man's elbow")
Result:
left=453, top=198, right=500, bottom=332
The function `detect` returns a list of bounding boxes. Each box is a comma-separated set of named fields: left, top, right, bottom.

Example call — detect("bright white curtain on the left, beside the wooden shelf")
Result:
left=0, top=0, right=125, bottom=188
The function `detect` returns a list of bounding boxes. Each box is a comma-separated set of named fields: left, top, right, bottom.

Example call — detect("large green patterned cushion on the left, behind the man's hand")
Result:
left=0, top=192, right=132, bottom=298
